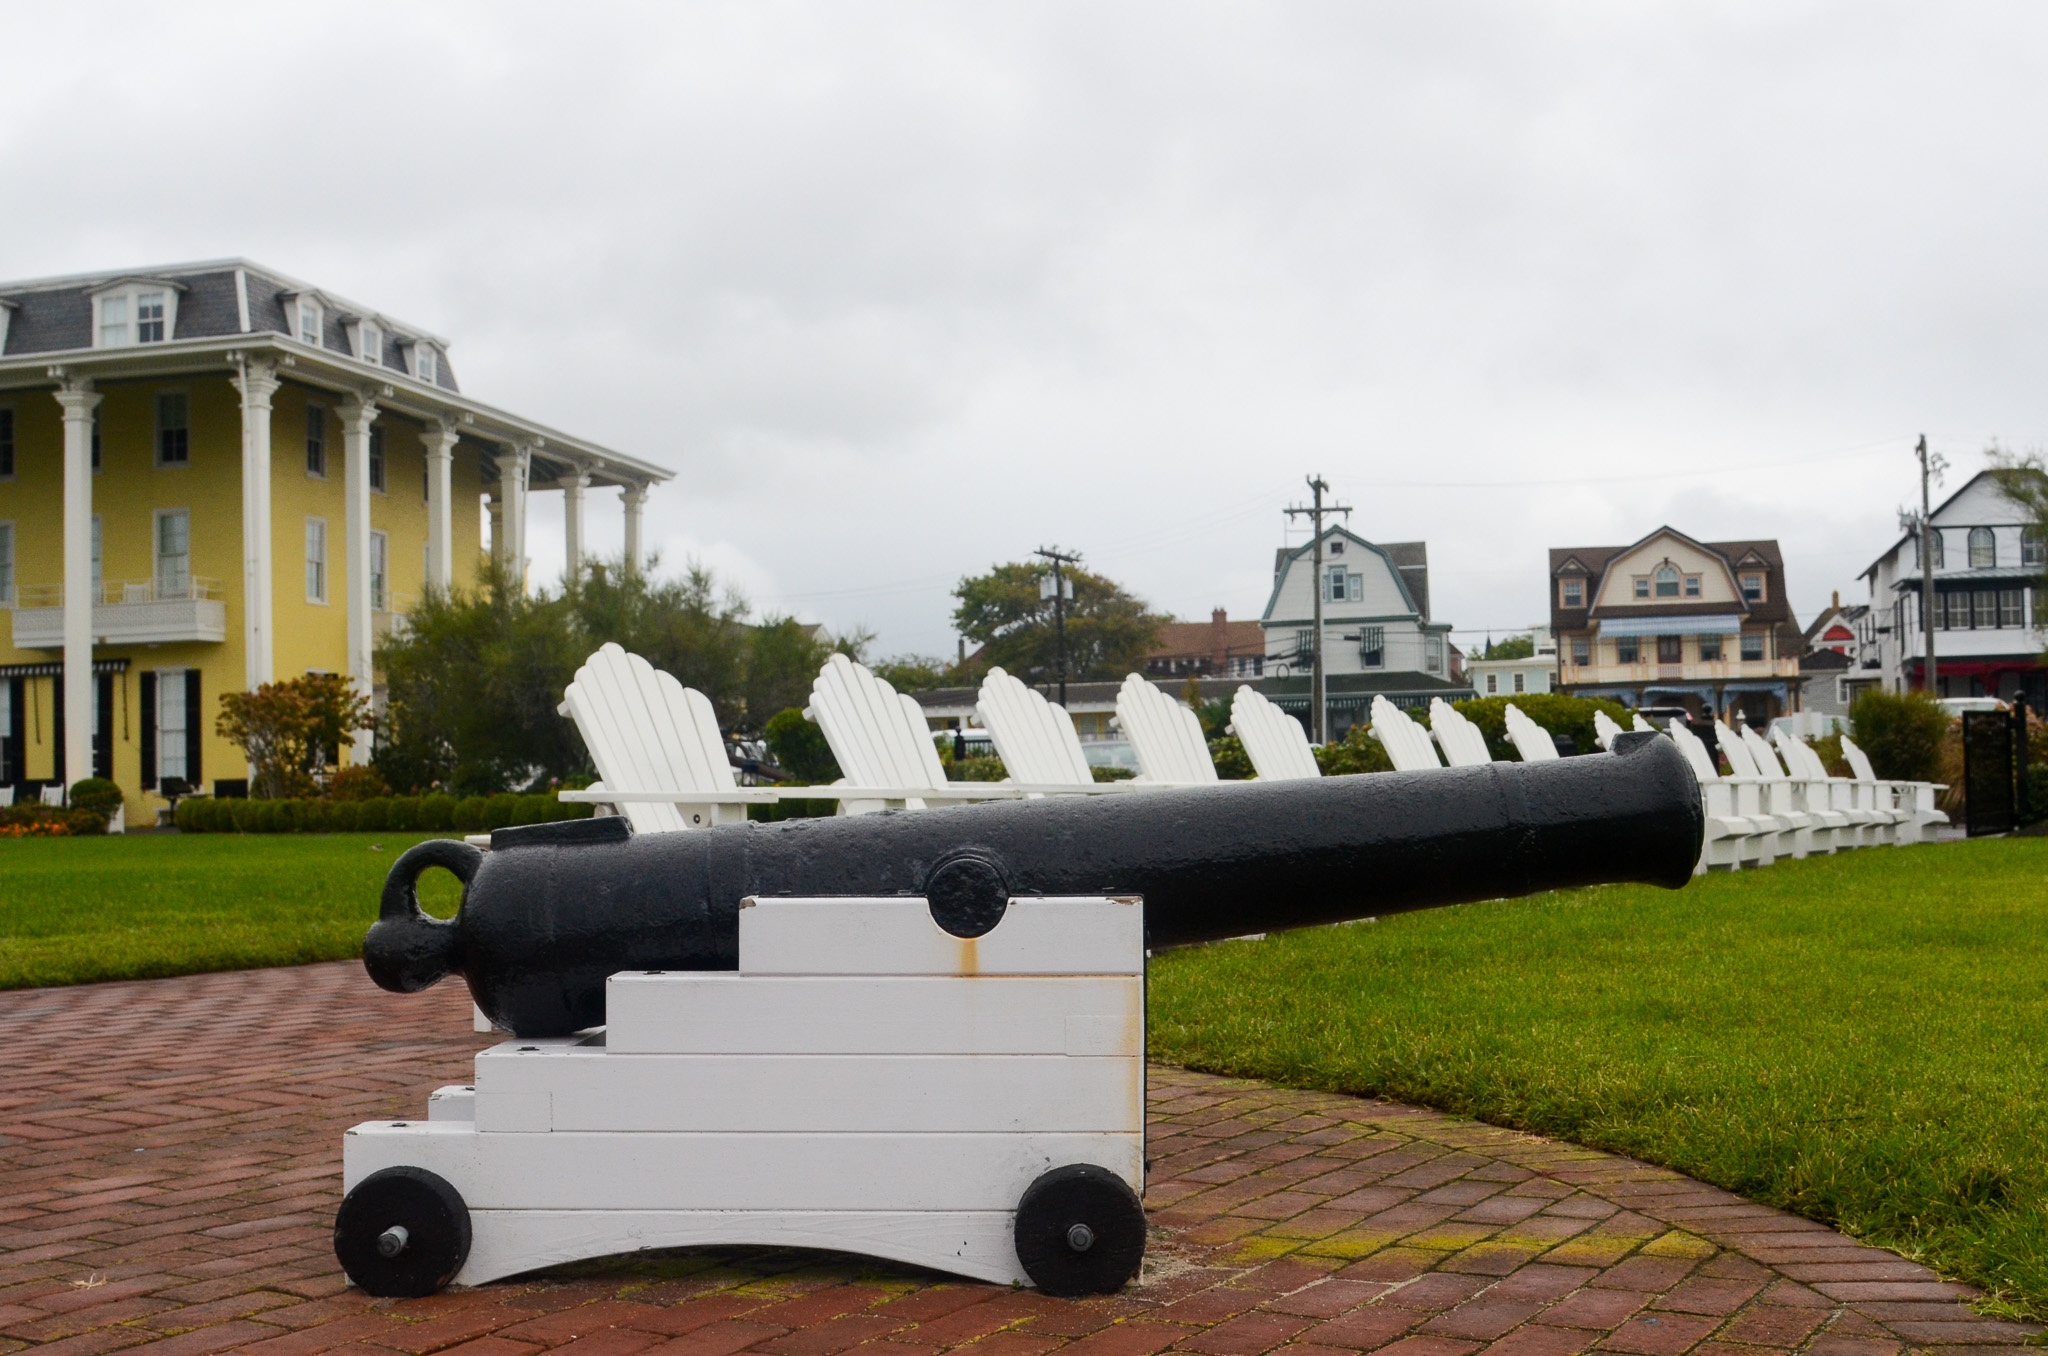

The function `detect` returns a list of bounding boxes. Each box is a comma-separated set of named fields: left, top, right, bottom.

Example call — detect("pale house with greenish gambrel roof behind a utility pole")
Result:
left=1260, top=526, right=1473, bottom=739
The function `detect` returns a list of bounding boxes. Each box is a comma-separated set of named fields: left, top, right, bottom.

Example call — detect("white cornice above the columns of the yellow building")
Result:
left=0, top=330, right=676, bottom=488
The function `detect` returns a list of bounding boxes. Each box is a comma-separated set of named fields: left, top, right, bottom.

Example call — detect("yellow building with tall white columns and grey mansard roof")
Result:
left=0, top=260, right=670, bottom=823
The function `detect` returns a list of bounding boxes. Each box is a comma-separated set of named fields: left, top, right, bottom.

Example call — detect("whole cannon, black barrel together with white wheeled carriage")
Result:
left=336, top=735, right=1702, bottom=1295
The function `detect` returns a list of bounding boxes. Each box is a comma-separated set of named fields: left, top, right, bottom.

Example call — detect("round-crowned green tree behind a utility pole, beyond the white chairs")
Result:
left=952, top=561, right=1167, bottom=682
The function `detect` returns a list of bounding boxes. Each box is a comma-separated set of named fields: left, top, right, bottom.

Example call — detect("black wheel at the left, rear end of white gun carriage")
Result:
left=334, top=1168, right=469, bottom=1299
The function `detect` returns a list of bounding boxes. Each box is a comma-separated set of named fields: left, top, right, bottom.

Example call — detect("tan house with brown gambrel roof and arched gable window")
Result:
left=1550, top=526, right=1804, bottom=725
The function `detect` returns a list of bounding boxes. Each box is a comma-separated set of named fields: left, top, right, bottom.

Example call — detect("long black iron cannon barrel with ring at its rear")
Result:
left=362, top=735, right=1704, bottom=1036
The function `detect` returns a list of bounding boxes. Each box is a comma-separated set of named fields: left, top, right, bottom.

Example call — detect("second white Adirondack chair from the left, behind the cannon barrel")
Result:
left=803, top=653, right=1020, bottom=815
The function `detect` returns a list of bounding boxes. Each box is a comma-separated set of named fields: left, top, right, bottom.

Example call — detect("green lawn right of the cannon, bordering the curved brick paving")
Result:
left=1149, top=838, right=2048, bottom=1319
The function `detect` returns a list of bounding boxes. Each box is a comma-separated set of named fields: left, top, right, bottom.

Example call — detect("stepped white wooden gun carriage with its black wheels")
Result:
left=336, top=897, right=1145, bottom=1295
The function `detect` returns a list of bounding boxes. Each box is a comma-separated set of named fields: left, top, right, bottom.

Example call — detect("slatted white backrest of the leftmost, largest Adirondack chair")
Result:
left=563, top=643, right=737, bottom=834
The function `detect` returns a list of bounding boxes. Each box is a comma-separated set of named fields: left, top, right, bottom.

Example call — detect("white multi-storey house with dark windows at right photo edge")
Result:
left=1858, top=471, right=2048, bottom=707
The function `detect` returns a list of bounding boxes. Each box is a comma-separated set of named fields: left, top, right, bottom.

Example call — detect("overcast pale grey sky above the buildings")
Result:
left=0, top=0, right=2048, bottom=653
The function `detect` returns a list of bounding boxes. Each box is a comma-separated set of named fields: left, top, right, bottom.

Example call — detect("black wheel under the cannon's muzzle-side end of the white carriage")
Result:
left=1016, top=1163, right=1145, bottom=1295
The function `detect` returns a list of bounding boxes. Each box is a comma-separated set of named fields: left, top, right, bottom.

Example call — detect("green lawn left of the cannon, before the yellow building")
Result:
left=0, top=834, right=455, bottom=989
